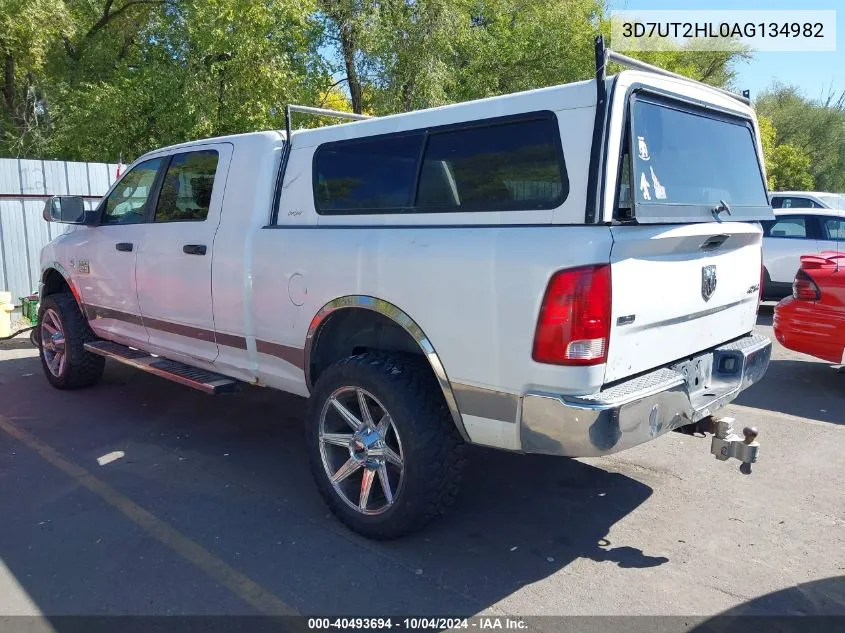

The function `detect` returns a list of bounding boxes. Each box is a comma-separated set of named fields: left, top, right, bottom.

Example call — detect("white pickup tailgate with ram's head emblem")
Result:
left=605, top=222, right=762, bottom=382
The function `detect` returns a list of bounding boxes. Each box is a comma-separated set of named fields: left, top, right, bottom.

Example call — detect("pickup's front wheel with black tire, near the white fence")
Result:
left=38, top=292, right=106, bottom=389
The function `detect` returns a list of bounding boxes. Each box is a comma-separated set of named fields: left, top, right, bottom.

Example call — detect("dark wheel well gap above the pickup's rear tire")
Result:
left=305, top=308, right=423, bottom=385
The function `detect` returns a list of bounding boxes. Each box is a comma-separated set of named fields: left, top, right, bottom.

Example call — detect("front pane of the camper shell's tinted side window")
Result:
left=314, top=133, right=423, bottom=215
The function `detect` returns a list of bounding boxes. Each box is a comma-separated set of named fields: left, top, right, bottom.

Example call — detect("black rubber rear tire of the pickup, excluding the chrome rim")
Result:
left=306, top=352, right=465, bottom=540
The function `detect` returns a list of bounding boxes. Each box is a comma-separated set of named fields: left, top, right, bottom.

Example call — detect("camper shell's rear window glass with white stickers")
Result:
left=623, top=97, right=773, bottom=222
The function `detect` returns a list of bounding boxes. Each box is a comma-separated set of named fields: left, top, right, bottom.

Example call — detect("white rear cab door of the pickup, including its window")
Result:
left=136, top=143, right=232, bottom=362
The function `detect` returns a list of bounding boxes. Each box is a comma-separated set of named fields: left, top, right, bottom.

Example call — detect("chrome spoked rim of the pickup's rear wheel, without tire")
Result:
left=318, top=387, right=405, bottom=515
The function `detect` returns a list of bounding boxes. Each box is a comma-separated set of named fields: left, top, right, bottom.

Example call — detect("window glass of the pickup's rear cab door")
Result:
left=153, top=150, right=218, bottom=222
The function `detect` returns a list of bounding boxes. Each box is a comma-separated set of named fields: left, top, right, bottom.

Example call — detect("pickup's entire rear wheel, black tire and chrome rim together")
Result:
left=306, top=352, right=464, bottom=540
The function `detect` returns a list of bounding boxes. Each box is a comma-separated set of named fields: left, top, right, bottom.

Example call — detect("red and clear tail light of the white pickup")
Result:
left=532, top=264, right=611, bottom=365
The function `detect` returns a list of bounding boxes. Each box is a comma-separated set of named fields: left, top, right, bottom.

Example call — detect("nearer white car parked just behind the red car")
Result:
left=762, top=207, right=845, bottom=301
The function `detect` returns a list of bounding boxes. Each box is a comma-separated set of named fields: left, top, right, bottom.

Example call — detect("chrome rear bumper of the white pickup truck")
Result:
left=520, top=335, right=772, bottom=457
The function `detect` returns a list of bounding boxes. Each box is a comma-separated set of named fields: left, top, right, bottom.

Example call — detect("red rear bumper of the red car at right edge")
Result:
left=774, top=297, right=845, bottom=365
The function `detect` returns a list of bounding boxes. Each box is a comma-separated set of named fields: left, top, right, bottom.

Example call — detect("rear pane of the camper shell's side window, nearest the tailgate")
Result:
left=417, top=117, right=568, bottom=212
